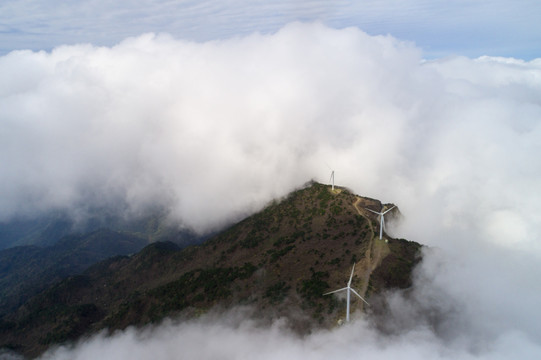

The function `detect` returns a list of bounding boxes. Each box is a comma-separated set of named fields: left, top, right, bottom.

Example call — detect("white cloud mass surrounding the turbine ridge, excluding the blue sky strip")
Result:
left=0, top=23, right=541, bottom=358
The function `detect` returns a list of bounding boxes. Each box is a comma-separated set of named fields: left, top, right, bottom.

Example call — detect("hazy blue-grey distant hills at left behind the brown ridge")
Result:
left=0, top=211, right=205, bottom=318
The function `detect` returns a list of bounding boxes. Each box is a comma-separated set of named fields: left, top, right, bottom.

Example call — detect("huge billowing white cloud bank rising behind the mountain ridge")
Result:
left=0, top=24, right=426, bottom=230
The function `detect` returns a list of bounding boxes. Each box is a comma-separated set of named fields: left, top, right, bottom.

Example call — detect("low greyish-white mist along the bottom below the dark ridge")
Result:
left=40, top=306, right=541, bottom=360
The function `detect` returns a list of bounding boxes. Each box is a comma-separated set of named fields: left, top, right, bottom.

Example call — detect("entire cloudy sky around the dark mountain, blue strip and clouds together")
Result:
left=0, top=1, right=541, bottom=360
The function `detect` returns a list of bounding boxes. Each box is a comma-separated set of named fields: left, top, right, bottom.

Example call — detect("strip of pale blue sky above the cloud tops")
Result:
left=0, top=0, right=541, bottom=60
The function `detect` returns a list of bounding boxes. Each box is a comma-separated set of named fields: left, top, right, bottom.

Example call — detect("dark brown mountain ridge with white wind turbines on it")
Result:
left=0, top=183, right=420, bottom=355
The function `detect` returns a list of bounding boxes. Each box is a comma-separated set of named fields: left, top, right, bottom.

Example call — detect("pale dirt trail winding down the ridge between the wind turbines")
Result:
left=353, top=196, right=389, bottom=309
